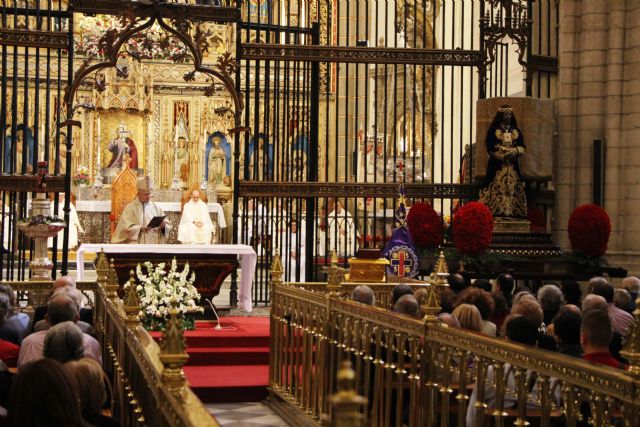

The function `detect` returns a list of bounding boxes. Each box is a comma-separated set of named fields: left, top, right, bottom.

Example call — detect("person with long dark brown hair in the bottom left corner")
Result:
left=7, top=359, right=86, bottom=427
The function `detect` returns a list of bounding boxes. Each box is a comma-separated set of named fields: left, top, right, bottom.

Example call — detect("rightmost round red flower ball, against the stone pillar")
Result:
left=569, top=204, right=611, bottom=257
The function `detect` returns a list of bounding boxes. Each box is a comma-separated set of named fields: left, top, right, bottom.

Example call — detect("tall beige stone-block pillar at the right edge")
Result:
left=554, top=0, right=640, bottom=274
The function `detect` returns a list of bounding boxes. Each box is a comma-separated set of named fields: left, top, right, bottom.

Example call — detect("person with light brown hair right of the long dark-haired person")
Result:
left=64, top=359, right=120, bottom=427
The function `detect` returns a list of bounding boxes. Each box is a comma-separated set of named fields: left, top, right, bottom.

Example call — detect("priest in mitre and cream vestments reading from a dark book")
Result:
left=111, top=176, right=171, bottom=244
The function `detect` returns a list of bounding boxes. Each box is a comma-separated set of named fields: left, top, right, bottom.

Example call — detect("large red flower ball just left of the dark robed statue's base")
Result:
left=453, top=202, right=493, bottom=256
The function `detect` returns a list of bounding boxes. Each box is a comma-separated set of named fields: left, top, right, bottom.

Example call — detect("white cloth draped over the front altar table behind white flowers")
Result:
left=76, top=243, right=258, bottom=312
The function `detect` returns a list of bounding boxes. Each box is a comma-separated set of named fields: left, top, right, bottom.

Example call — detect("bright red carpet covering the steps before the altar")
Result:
left=151, top=317, right=269, bottom=403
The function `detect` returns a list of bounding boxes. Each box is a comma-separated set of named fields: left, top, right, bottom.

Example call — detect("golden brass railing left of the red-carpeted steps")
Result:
left=3, top=253, right=219, bottom=427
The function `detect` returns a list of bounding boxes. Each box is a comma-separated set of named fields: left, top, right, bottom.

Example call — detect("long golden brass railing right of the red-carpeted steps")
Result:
left=269, top=258, right=640, bottom=427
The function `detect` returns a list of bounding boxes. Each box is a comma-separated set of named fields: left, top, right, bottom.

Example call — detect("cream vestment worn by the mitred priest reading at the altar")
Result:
left=111, top=198, right=171, bottom=244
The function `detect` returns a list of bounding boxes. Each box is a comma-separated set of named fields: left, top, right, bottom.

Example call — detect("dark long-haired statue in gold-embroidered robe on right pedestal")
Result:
left=480, top=105, right=527, bottom=218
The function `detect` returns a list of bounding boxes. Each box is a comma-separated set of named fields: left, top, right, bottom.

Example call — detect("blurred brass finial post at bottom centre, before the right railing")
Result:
left=331, top=360, right=367, bottom=427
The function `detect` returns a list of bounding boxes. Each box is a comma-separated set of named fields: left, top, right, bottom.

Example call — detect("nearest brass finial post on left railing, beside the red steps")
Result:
left=160, top=308, right=189, bottom=400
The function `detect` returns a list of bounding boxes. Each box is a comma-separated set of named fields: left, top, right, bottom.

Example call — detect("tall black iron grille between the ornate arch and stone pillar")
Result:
left=234, top=0, right=557, bottom=303
